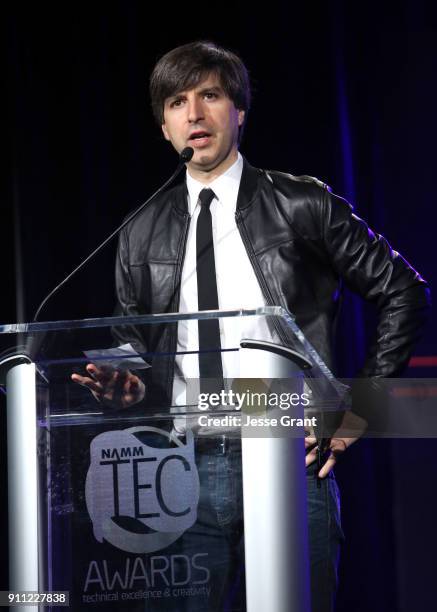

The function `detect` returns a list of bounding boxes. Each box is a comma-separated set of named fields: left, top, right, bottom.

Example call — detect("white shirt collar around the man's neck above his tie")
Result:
left=186, top=152, right=243, bottom=215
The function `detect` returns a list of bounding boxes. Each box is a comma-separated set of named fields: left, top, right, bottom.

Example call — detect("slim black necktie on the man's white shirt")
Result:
left=196, top=189, right=223, bottom=393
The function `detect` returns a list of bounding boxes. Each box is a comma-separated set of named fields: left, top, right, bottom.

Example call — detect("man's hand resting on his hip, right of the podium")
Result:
left=305, top=410, right=367, bottom=478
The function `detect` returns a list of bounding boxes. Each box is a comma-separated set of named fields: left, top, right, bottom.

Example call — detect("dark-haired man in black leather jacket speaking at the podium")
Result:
left=73, top=42, right=428, bottom=612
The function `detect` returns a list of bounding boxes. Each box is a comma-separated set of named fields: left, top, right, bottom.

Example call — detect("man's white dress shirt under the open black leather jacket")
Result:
left=173, top=153, right=275, bottom=414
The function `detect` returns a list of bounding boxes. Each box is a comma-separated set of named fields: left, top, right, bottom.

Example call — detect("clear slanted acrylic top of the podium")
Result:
left=0, top=306, right=345, bottom=420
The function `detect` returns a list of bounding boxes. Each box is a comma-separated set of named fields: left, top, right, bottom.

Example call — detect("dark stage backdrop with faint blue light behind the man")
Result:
left=0, top=0, right=437, bottom=612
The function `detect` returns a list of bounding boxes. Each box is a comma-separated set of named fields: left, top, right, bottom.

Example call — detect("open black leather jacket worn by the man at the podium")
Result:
left=112, top=161, right=429, bottom=403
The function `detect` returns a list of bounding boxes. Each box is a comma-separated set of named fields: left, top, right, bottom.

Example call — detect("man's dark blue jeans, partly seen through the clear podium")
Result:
left=167, top=443, right=344, bottom=612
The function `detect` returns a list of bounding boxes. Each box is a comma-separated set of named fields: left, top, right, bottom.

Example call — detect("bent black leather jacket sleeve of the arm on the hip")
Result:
left=318, top=188, right=430, bottom=378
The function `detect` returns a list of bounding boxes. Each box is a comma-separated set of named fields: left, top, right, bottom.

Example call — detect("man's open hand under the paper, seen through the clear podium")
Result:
left=71, top=363, right=146, bottom=408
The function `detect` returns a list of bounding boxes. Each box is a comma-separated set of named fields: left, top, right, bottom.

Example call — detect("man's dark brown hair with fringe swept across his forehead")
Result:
left=150, top=40, right=251, bottom=139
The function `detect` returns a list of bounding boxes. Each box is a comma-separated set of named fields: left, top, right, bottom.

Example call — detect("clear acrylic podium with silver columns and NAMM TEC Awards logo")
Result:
left=0, top=307, right=344, bottom=612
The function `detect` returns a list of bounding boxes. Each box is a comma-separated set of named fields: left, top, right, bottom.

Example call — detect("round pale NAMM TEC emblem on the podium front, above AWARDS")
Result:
left=85, top=427, right=199, bottom=553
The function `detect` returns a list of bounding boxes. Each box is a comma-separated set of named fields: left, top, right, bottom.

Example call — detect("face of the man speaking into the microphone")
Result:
left=162, top=73, right=244, bottom=177
